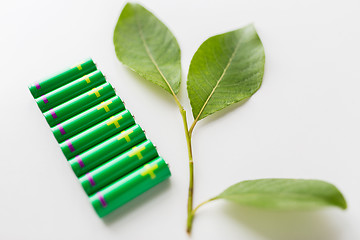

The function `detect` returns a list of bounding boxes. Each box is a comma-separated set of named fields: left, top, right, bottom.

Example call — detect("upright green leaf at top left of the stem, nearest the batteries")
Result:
left=114, top=3, right=181, bottom=94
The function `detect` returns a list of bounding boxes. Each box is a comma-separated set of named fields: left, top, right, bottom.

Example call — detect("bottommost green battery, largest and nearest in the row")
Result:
left=90, top=157, right=171, bottom=217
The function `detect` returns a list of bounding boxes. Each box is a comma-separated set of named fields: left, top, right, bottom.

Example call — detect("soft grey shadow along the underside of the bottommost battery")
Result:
left=102, top=179, right=171, bottom=226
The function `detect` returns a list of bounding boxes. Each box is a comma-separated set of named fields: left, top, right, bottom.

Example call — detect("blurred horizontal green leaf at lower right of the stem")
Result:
left=214, top=179, right=346, bottom=210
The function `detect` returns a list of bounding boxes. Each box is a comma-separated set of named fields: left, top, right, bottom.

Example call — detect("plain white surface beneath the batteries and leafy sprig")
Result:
left=0, top=0, right=360, bottom=240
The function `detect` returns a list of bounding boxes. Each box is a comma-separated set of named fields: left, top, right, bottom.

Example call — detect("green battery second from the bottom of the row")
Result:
left=79, top=140, right=158, bottom=195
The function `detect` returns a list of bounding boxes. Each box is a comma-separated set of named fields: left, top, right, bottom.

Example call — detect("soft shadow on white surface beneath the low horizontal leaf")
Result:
left=223, top=203, right=341, bottom=240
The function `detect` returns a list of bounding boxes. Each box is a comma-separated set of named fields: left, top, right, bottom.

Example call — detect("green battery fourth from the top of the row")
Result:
left=51, top=96, right=125, bottom=143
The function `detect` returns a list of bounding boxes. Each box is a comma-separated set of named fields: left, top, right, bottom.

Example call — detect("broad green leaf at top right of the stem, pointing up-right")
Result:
left=187, top=25, right=265, bottom=121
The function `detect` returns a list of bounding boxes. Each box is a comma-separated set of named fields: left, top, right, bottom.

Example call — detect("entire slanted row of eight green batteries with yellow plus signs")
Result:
left=29, top=59, right=171, bottom=217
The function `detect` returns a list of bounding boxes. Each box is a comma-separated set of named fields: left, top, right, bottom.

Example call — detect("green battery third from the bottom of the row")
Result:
left=69, top=124, right=146, bottom=177
